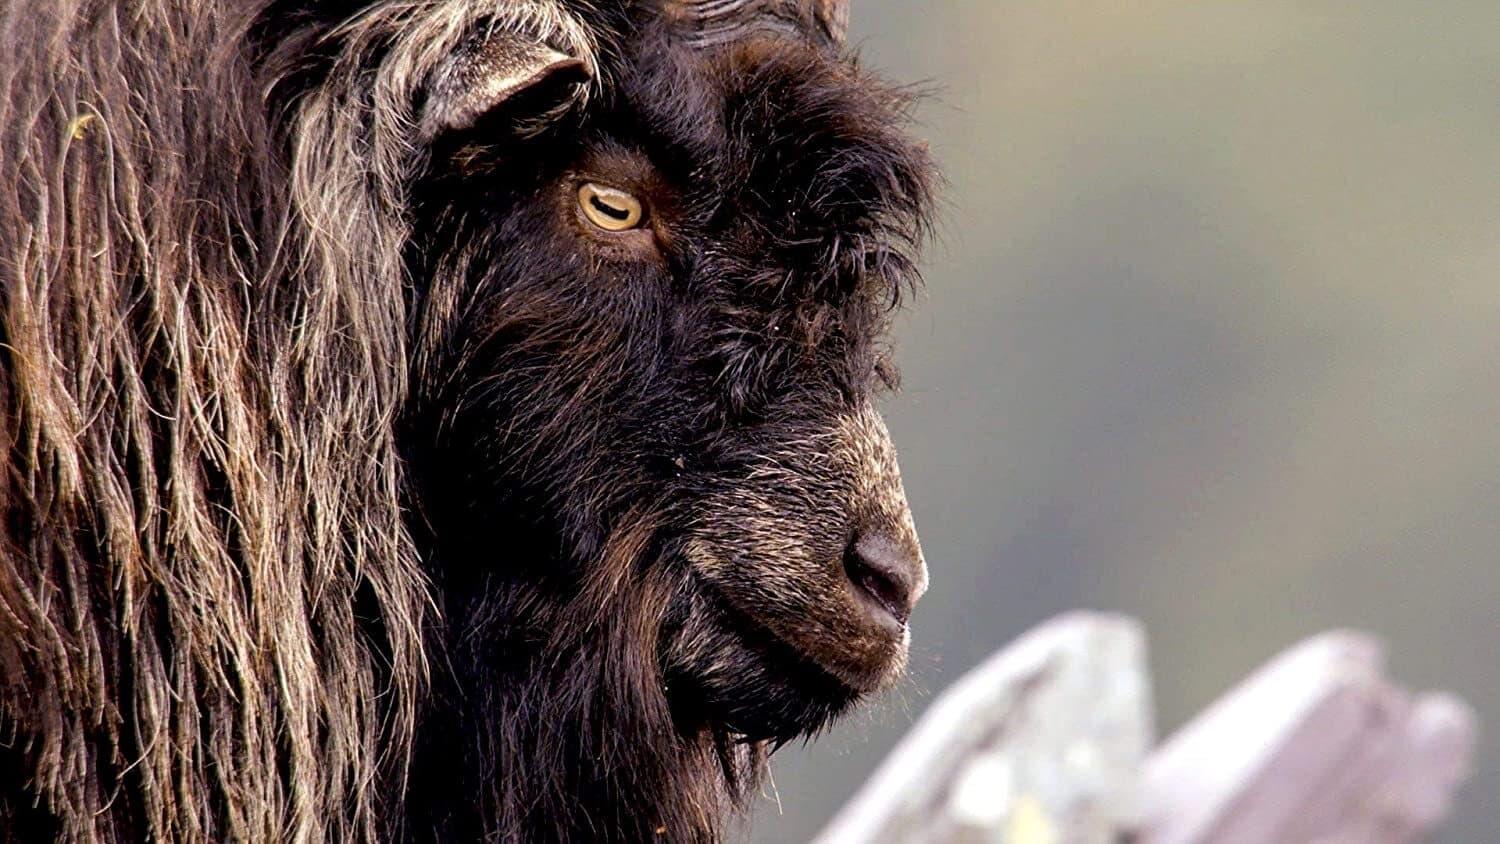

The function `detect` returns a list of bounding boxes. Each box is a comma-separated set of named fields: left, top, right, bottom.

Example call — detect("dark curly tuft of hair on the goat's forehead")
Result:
left=606, top=37, right=932, bottom=287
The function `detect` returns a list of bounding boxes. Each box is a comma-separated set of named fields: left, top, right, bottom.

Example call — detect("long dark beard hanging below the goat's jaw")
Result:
left=407, top=519, right=860, bottom=841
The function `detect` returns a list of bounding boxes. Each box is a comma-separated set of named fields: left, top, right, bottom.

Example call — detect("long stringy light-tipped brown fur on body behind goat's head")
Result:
left=0, top=0, right=431, bottom=841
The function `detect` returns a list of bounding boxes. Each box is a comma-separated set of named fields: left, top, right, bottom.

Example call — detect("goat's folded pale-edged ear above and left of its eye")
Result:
left=419, top=31, right=590, bottom=142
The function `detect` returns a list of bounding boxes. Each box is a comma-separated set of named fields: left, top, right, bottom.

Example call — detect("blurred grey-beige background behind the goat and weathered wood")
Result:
left=743, top=0, right=1500, bottom=843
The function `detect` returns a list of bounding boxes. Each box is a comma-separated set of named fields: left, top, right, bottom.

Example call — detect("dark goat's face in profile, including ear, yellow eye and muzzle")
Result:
left=405, top=4, right=932, bottom=739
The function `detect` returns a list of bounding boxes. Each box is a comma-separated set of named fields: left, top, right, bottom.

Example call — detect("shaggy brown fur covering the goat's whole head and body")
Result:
left=0, top=0, right=930, bottom=841
